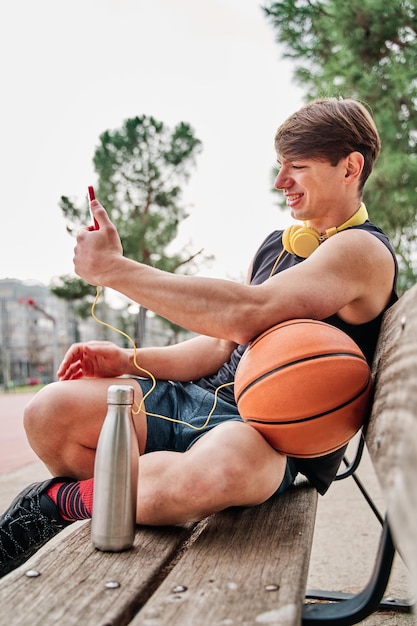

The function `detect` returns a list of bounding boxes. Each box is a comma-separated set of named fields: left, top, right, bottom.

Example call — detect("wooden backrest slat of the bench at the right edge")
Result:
left=366, top=285, right=417, bottom=586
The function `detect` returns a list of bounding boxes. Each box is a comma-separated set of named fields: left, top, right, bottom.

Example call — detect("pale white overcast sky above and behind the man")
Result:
left=0, top=0, right=304, bottom=284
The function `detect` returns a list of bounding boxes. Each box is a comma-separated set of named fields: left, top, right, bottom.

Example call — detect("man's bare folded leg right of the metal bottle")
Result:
left=133, top=421, right=286, bottom=525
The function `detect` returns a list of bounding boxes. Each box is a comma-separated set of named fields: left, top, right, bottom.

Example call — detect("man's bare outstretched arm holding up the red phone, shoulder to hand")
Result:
left=74, top=201, right=394, bottom=343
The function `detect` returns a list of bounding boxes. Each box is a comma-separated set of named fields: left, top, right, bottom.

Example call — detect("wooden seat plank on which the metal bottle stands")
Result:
left=0, top=522, right=197, bottom=626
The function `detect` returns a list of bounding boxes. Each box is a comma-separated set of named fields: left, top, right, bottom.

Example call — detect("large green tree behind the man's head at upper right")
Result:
left=264, top=0, right=417, bottom=289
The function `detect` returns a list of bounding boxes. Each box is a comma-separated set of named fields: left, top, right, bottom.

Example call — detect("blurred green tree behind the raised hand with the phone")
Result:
left=60, top=115, right=202, bottom=345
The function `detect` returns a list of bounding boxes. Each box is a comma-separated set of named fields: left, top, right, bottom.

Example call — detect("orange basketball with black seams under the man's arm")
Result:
left=235, top=319, right=372, bottom=458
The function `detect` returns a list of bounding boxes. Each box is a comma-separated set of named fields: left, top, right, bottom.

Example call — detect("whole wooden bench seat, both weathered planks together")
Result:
left=0, top=486, right=317, bottom=626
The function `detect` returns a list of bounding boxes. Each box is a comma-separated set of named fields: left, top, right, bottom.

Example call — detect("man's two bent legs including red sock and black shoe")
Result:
left=0, top=379, right=286, bottom=576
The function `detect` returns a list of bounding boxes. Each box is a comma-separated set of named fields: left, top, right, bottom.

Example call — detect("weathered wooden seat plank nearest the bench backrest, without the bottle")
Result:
left=131, top=486, right=317, bottom=626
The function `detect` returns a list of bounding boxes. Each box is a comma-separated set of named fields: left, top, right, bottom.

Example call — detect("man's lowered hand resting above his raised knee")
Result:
left=57, top=341, right=130, bottom=380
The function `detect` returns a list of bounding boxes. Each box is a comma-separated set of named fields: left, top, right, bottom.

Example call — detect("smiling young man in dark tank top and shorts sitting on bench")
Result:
left=0, top=98, right=397, bottom=575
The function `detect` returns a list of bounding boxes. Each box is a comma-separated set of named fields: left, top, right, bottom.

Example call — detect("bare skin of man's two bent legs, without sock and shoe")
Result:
left=25, top=379, right=286, bottom=525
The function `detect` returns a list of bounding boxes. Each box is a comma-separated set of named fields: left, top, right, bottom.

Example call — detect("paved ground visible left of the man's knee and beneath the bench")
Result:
left=0, top=392, right=417, bottom=626
